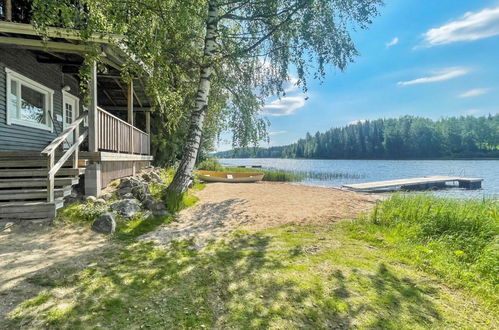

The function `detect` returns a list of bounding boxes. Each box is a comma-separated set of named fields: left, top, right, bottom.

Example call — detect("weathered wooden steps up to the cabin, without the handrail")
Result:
left=0, top=152, right=86, bottom=220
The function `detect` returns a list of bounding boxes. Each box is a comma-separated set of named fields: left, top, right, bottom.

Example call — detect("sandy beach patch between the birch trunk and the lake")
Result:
left=141, top=182, right=377, bottom=248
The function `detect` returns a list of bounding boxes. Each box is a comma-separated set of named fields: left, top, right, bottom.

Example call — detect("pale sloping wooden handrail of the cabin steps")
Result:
left=41, top=112, right=88, bottom=203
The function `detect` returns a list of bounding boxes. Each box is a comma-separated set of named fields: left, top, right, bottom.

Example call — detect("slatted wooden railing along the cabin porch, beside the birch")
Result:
left=97, top=108, right=150, bottom=155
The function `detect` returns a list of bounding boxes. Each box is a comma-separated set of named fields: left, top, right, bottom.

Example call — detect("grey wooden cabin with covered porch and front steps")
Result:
left=0, top=12, right=152, bottom=219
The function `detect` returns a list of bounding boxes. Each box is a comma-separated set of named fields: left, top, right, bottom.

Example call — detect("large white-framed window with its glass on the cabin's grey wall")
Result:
left=5, top=69, right=54, bottom=131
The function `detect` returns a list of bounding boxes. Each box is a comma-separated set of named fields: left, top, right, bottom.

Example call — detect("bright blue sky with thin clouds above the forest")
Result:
left=218, top=0, right=499, bottom=150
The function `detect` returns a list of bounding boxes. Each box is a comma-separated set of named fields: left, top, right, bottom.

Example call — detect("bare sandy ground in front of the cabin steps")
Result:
left=0, top=226, right=109, bottom=322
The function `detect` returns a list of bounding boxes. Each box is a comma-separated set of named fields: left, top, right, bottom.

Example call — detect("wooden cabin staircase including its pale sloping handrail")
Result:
left=0, top=112, right=88, bottom=220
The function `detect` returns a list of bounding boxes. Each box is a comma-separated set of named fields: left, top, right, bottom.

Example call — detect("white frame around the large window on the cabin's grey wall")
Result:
left=5, top=68, right=54, bottom=132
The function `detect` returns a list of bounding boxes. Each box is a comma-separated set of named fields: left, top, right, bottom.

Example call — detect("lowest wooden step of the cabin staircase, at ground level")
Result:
left=0, top=198, right=64, bottom=220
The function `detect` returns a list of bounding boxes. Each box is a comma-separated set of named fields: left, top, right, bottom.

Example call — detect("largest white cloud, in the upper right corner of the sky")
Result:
left=423, top=7, right=499, bottom=46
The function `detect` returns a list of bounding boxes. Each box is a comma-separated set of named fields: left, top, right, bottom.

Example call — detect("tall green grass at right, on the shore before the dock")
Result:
left=352, top=195, right=499, bottom=303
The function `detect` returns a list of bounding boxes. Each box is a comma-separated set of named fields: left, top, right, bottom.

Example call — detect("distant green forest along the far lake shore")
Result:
left=215, top=114, right=499, bottom=159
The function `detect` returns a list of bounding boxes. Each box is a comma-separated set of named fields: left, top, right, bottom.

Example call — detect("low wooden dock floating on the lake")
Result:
left=342, top=176, right=483, bottom=192
